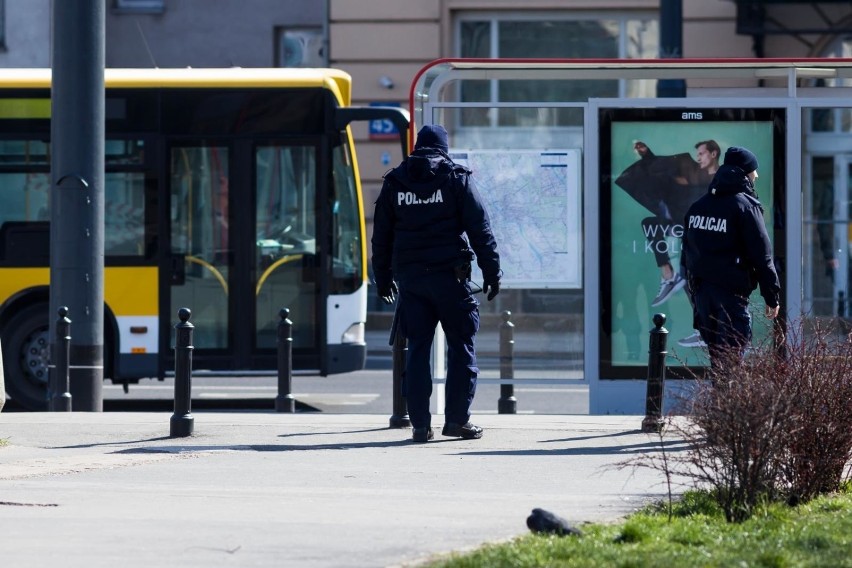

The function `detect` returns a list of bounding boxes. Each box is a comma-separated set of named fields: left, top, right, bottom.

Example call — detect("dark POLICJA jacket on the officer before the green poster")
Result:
left=681, top=165, right=781, bottom=307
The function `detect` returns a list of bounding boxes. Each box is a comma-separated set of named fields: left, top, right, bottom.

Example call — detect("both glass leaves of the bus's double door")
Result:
left=164, top=139, right=321, bottom=371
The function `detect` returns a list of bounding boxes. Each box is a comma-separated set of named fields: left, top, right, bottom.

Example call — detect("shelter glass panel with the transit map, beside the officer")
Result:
left=429, top=106, right=584, bottom=379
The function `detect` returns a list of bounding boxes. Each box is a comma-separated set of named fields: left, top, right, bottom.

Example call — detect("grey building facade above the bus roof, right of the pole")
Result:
left=106, top=0, right=328, bottom=67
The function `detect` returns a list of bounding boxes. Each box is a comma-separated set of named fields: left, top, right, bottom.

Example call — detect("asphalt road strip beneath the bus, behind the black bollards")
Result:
left=3, top=332, right=589, bottom=417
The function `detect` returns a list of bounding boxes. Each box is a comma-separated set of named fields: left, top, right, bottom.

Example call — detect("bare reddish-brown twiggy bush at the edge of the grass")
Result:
left=655, top=323, right=852, bottom=522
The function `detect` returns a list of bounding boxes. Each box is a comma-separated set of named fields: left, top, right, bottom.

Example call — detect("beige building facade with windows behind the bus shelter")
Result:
left=328, top=0, right=852, bottom=214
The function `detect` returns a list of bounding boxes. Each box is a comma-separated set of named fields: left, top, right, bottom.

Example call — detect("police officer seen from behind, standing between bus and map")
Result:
left=372, top=125, right=502, bottom=442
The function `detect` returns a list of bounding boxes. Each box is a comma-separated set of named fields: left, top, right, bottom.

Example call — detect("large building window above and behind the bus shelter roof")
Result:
left=455, top=12, right=659, bottom=126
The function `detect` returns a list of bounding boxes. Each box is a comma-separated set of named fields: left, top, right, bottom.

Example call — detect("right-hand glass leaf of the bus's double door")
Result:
left=253, top=141, right=327, bottom=370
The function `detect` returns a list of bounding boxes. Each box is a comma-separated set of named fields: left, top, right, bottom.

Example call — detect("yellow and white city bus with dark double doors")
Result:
left=0, top=68, right=408, bottom=409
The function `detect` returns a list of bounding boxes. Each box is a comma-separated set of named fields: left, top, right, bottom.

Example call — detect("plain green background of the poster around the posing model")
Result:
left=609, top=121, right=775, bottom=367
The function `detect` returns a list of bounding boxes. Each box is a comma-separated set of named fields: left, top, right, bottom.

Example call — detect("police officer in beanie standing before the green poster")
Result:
left=681, top=146, right=781, bottom=367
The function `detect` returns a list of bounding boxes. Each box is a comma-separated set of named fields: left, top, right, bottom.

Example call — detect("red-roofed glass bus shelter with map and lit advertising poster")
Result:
left=410, top=59, right=852, bottom=414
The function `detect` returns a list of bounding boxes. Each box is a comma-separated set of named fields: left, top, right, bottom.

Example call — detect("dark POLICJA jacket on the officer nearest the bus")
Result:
left=372, top=148, right=500, bottom=288
